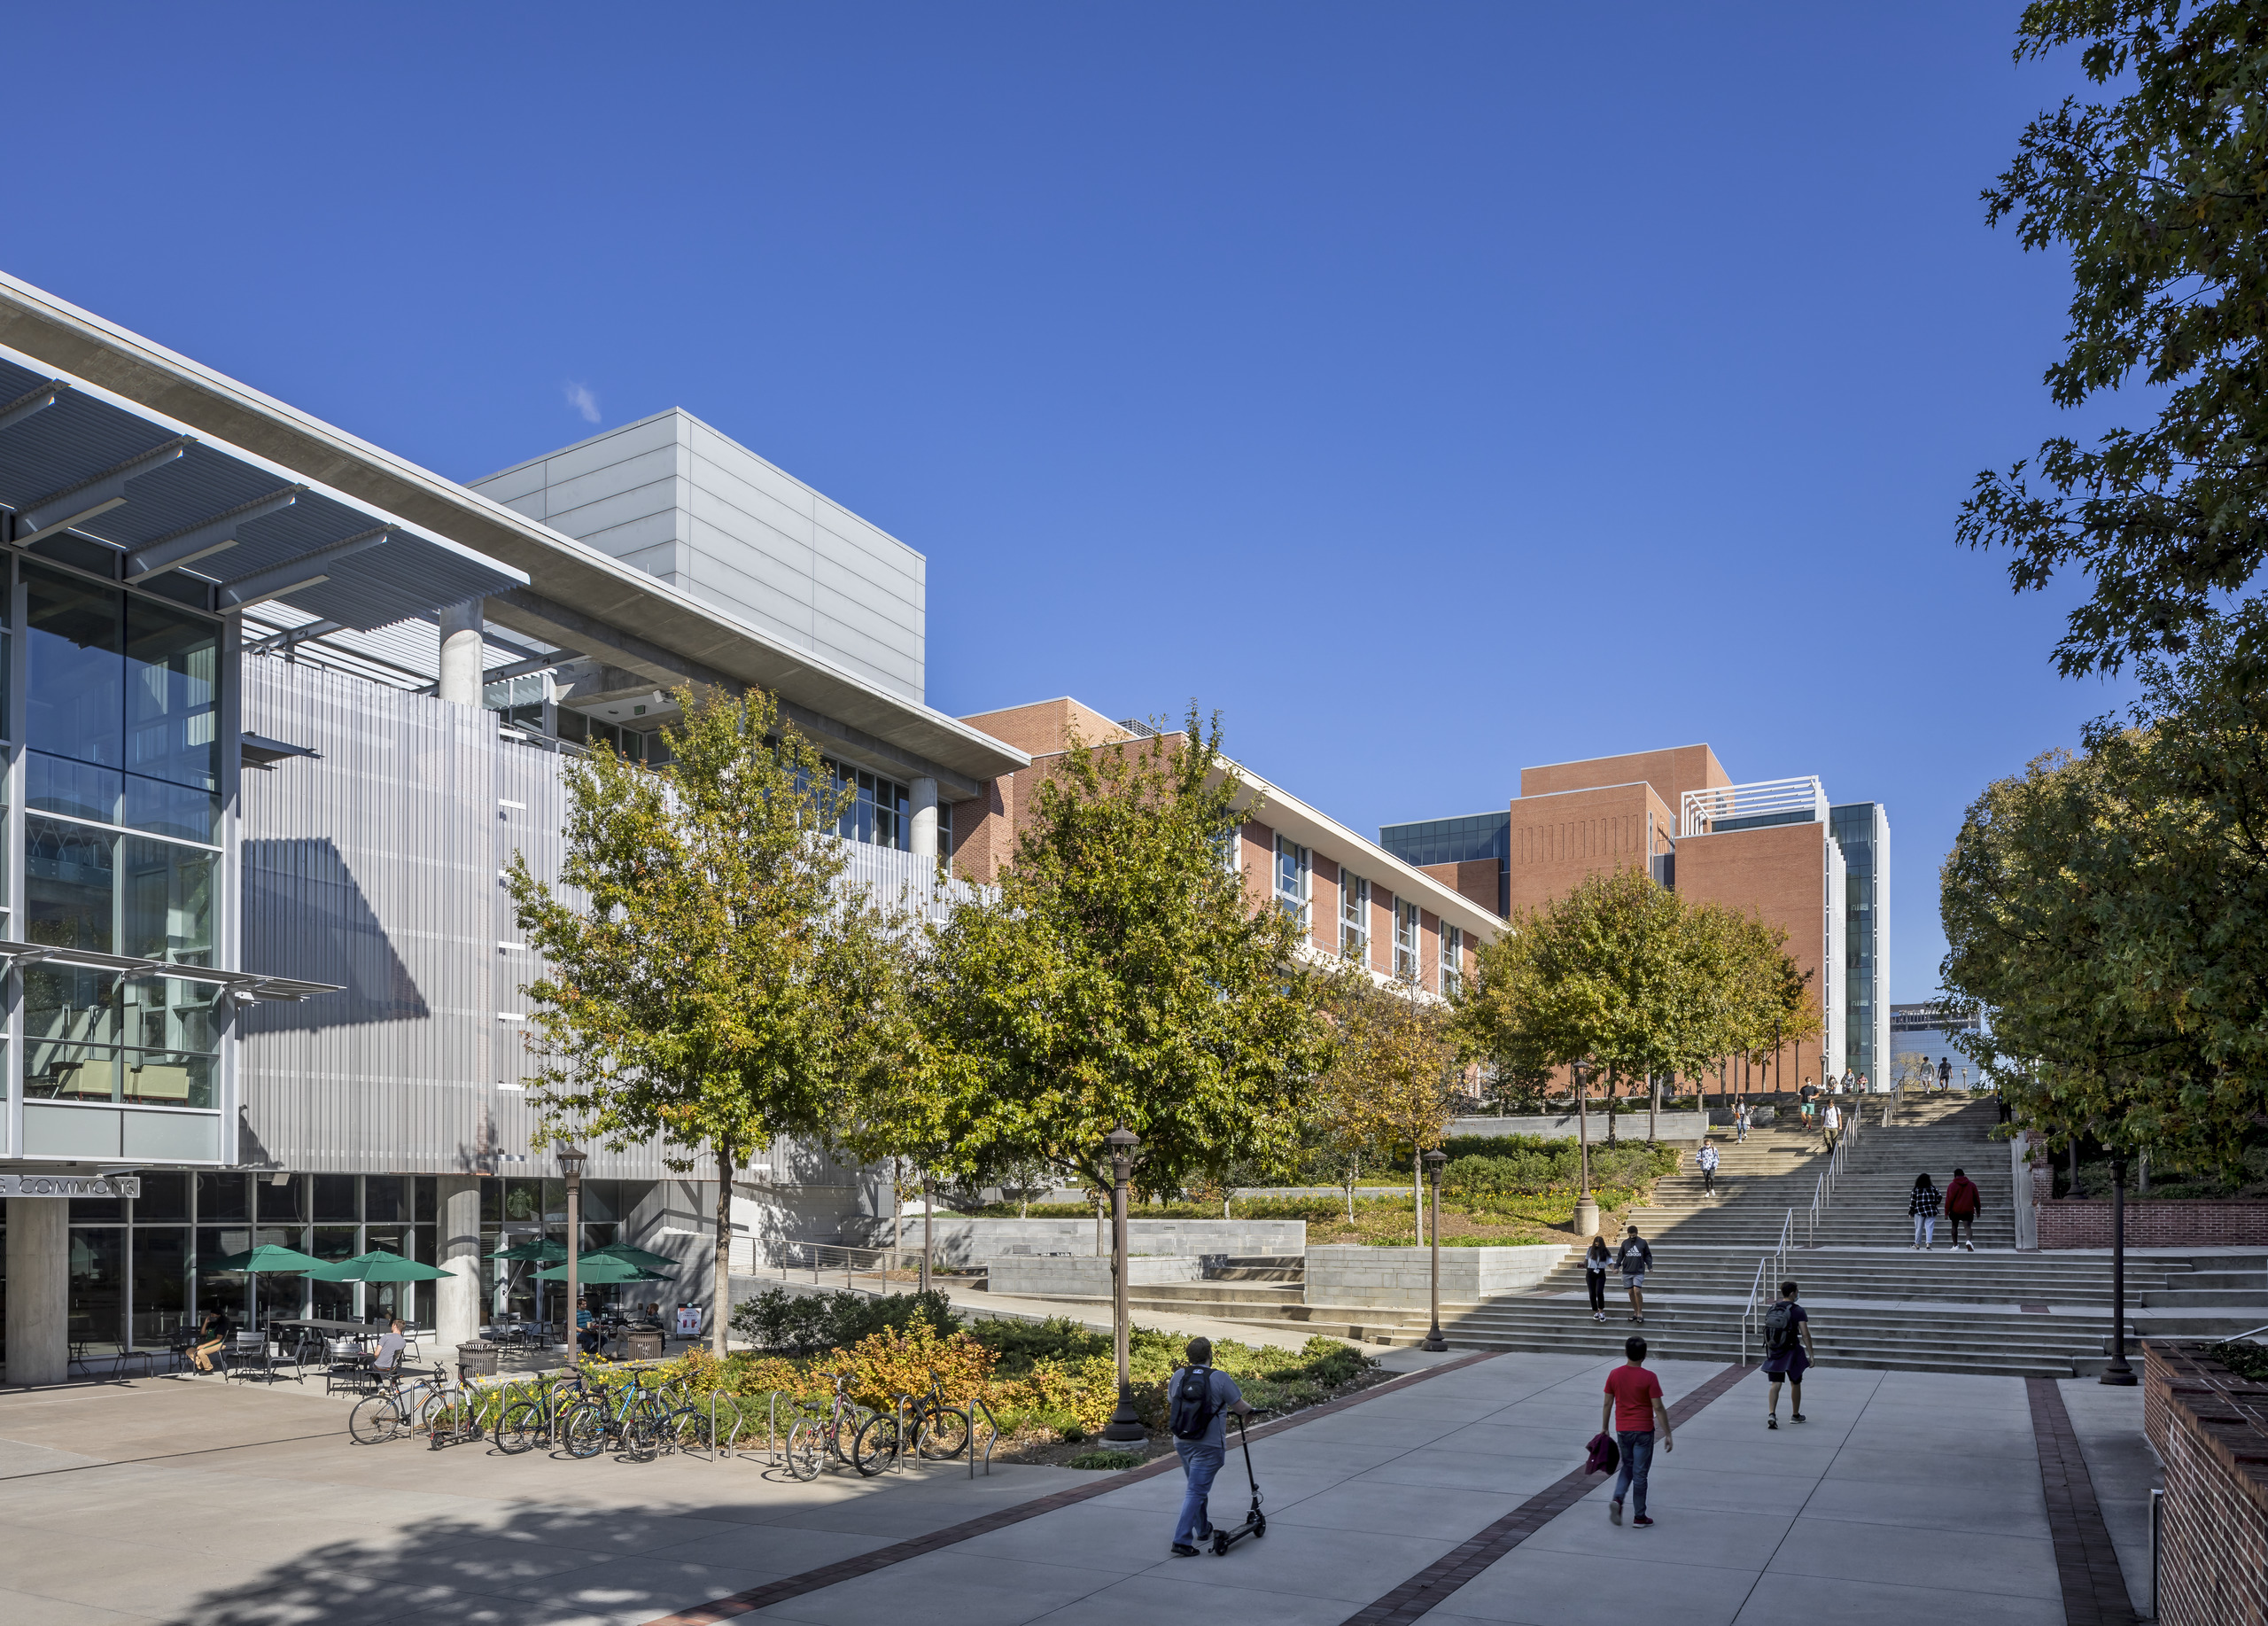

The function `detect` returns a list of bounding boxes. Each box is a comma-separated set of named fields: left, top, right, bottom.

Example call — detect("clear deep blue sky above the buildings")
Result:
left=0, top=0, right=2141, bottom=1000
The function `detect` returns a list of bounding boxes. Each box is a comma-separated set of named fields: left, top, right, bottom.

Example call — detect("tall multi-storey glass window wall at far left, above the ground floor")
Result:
left=18, top=563, right=220, bottom=1111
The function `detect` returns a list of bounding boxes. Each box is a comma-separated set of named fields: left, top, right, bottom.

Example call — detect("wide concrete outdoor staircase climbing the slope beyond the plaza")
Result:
left=1131, top=1098, right=2268, bottom=1376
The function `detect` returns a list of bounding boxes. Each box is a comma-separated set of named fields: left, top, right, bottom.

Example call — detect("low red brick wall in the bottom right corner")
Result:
left=2141, top=1342, right=2268, bottom=1626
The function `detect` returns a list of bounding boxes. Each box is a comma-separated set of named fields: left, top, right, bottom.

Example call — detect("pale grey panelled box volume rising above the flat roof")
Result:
left=470, top=406, right=928, bottom=701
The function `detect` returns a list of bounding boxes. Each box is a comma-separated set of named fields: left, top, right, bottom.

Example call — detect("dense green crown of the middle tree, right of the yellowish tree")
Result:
left=914, top=710, right=1329, bottom=1193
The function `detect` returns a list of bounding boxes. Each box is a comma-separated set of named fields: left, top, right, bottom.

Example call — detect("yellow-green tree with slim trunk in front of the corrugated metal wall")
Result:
left=508, top=689, right=907, bottom=1356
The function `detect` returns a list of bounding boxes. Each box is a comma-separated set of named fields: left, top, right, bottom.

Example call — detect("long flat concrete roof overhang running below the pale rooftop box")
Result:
left=0, top=272, right=1029, bottom=784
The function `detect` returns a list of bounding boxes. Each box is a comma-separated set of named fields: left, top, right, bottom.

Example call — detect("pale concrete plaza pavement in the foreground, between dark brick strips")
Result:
left=0, top=1351, right=2155, bottom=1626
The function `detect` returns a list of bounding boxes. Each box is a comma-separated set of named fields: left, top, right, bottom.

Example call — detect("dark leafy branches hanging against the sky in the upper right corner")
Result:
left=1960, top=0, right=2268, bottom=681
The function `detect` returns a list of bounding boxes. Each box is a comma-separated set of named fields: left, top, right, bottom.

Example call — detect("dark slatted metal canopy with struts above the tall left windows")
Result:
left=0, top=347, right=528, bottom=630
